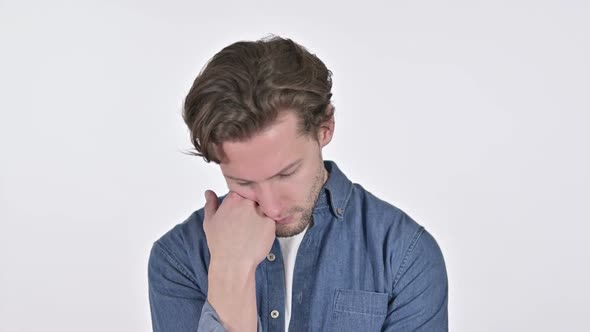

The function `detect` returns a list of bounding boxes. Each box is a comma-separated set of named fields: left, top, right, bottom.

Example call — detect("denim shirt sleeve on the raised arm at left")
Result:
left=148, top=242, right=262, bottom=332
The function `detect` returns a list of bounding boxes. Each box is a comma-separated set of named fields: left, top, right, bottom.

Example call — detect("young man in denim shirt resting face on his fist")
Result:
left=149, top=37, right=448, bottom=332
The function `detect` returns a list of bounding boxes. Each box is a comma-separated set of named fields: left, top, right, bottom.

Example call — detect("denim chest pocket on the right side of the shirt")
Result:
left=328, top=289, right=389, bottom=332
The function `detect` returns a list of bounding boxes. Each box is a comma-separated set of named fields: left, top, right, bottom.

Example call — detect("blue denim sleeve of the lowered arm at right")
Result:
left=383, top=229, right=448, bottom=331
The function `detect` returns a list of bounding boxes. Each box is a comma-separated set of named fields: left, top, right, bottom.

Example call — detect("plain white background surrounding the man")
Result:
left=0, top=0, right=590, bottom=332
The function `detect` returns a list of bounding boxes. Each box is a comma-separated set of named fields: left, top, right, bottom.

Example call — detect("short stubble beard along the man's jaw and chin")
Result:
left=276, top=162, right=328, bottom=237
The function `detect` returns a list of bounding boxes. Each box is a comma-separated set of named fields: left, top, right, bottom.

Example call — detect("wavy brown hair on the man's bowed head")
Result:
left=183, top=37, right=334, bottom=164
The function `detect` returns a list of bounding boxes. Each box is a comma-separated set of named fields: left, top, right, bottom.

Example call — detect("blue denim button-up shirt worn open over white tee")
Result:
left=148, top=161, right=448, bottom=332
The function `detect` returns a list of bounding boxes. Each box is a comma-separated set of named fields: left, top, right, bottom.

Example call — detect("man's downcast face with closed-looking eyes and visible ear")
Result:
left=220, top=111, right=334, bottom=237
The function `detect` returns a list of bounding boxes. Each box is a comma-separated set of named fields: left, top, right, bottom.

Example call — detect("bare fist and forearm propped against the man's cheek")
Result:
left=203, top=190, right=276, bottom=331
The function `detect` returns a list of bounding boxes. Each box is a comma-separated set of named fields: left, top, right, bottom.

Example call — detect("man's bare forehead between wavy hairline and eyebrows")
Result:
left=220, top=112, right=310, bottom=181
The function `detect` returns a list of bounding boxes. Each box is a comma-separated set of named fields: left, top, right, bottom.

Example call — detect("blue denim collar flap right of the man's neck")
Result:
left=315, top=160, right=352, bottom=220
